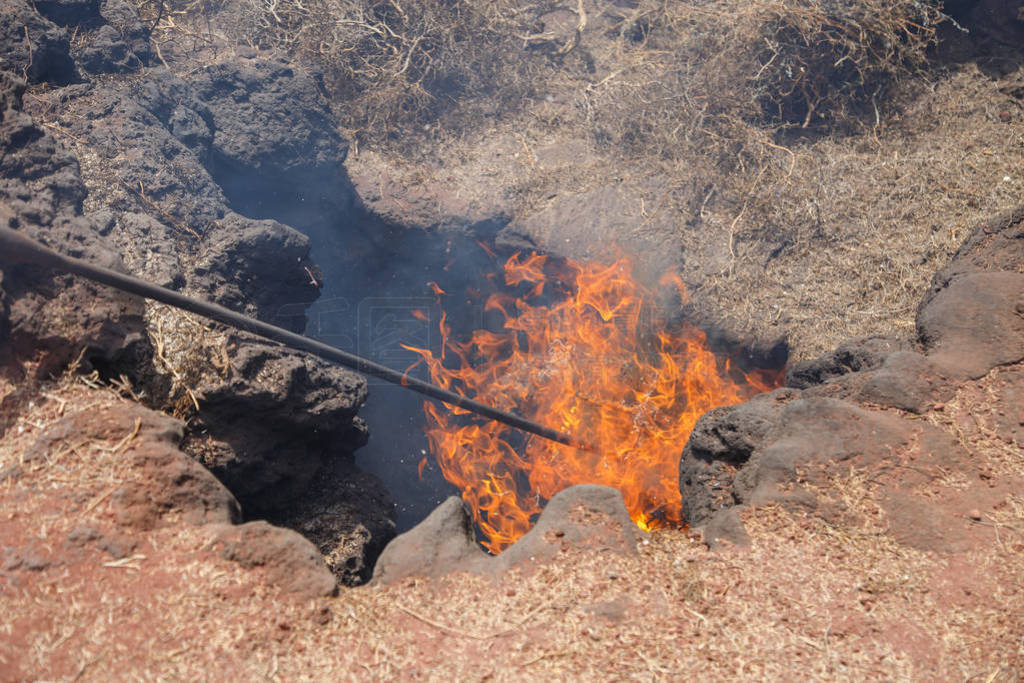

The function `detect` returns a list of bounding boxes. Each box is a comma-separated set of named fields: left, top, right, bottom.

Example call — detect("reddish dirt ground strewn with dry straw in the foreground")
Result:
left=0, top=366, right=1024, bottom=681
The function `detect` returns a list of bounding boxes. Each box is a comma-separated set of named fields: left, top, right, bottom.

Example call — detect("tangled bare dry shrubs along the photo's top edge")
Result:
left=139, top=0, right=944, bottom=159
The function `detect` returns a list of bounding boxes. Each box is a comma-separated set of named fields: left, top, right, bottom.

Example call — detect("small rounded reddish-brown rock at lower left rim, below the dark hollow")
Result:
left=211, top=521, right=338, bottom=598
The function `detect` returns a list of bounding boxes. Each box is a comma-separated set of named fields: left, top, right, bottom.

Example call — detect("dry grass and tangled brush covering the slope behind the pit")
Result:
left=110, top=0, right=1024, bottom=359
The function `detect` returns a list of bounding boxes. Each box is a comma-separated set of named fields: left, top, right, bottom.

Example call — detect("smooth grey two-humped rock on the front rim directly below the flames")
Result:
left=374, top=484, right=643, bottom=584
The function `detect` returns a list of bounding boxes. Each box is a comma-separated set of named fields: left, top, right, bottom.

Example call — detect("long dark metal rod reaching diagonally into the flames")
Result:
left=0, top=227, right=592, bottom=450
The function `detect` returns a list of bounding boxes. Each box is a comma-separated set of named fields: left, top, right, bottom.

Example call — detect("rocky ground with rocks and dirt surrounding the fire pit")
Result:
left=0, top=0, right=1024, bottom=681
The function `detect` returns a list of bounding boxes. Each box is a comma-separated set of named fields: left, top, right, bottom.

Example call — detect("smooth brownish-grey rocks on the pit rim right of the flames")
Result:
left=680, top=210, right=1024, bottom=551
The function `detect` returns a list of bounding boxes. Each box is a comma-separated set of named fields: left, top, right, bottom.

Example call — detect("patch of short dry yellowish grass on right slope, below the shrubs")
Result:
left=693, top=66, right=1024, bottom=359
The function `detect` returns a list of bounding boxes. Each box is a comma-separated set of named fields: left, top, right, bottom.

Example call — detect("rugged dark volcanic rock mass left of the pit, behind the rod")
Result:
left=0, top=0, right=393, bottom=589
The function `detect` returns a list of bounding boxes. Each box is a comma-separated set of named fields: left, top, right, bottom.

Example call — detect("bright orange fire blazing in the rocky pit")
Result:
left=408, top=254, right=776, bottom=553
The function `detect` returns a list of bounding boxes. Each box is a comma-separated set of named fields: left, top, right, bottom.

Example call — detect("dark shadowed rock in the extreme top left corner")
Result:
left=0, top=0, right=78, bottom=85
